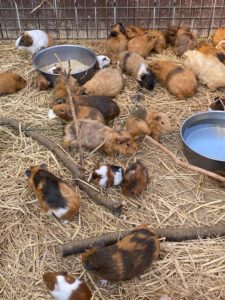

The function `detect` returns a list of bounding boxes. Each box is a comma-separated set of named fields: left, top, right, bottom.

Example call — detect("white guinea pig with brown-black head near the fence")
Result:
left=16, top=30, right=54, bottom=55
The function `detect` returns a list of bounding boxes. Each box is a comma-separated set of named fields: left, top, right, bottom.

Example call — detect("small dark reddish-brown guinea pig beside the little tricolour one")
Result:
left=121, top=161, right=148, bottom=196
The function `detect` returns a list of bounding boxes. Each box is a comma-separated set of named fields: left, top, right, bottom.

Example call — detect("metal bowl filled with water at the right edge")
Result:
left=180, top=111, right=225, bottom=171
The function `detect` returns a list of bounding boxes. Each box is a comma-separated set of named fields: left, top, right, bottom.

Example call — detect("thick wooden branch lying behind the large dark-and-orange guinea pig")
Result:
left=61, top=224, right=225, bottom=257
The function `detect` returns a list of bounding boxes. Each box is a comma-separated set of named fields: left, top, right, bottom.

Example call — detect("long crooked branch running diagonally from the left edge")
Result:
left=0, top=118, right=122, bottom=216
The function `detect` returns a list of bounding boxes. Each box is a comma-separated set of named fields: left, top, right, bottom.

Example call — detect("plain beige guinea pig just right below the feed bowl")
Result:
left=81, top=68, right=125, bottom=97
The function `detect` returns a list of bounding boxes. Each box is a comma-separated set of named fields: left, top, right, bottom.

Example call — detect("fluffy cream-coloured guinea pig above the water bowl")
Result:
left=183, top=50, right=225, bottom=91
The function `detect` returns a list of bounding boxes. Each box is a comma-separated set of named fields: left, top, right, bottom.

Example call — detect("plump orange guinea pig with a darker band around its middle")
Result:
left=148, top=60, right=197, bottom=99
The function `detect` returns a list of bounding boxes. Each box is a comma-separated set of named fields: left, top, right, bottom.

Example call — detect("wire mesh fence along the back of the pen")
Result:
left=0, top=0, right=225, bottom=39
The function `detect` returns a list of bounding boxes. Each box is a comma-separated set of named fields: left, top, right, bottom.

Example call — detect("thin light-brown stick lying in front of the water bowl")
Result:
left=145, top=135, right=225, bottom=183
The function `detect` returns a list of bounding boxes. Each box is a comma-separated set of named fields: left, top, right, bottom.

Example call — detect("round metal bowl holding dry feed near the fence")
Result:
left=33, top=45, right=97, bottom=86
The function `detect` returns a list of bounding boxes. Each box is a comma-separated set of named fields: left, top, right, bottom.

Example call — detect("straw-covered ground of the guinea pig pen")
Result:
left=0, top=40, right=225, bottom=300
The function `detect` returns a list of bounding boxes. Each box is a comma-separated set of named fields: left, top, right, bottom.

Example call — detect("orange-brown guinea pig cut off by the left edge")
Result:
left=0, top=73, right=27, bottom=96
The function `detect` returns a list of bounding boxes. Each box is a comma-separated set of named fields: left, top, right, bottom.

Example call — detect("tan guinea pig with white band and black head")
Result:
left=118, top=51, right=155, bottom=90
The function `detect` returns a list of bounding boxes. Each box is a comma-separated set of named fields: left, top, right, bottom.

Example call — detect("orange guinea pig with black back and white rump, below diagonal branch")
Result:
left=26, top=164, right=80, bottom=224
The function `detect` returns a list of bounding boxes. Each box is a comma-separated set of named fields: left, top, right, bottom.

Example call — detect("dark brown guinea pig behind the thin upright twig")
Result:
left=51, top=95, right=120, bottom=124
